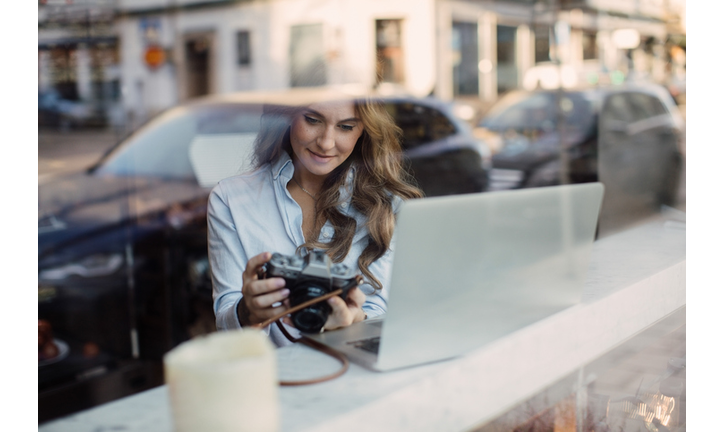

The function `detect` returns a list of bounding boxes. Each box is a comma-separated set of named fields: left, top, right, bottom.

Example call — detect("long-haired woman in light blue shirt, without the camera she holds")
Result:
left=208, top=99, right=422, bottom=346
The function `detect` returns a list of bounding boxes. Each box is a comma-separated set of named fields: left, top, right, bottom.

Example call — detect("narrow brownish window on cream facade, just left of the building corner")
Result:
left=375, top=20, right=405, bottom=84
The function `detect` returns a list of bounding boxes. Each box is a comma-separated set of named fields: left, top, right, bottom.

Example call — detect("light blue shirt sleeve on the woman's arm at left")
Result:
left=208, top=184, right=248, bottom=330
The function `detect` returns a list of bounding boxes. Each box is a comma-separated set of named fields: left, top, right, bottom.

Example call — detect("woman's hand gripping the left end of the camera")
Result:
left=238, top=252, right=289, bottom=326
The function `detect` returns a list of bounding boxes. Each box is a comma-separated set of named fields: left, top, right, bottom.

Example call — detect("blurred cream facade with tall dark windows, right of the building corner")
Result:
left=436, top=0, right=685, bottom=107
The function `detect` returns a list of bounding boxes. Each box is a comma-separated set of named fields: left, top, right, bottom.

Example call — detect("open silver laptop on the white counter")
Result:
left=306, top=183, right=603, bottom=371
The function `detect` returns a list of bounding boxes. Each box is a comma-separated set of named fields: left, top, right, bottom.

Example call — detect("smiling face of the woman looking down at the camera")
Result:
left=290, top=101, right=364, bottom=177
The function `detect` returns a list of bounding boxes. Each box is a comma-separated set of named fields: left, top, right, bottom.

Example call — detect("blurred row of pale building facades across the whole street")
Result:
left=39, top=0, right=685, bottom=129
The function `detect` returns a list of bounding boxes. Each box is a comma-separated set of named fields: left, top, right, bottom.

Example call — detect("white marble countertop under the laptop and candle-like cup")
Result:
left=38, top=212, right=686, bottom=432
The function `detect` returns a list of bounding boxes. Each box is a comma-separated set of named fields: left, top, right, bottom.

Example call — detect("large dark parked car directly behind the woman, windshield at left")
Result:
left=38, top=89, right=490, bottom=421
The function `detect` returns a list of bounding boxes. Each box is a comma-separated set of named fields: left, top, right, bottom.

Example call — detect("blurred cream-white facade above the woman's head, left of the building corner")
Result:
left=118, top=0, right=434, bottom=126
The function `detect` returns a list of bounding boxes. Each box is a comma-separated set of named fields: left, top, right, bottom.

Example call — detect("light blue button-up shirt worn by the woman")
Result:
left=208, top=152, right=402, bottom=346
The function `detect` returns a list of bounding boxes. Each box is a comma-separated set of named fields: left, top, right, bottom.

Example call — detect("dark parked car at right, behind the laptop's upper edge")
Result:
left=475, top=84, right=683, bottom=235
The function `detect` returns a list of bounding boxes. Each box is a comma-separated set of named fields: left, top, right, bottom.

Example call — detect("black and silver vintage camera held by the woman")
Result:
left=265, top=251, right=361, bottom=333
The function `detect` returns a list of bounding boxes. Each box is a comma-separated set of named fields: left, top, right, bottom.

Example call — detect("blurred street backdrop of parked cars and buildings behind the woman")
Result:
left=38, top=0, right=686, bottom=428
